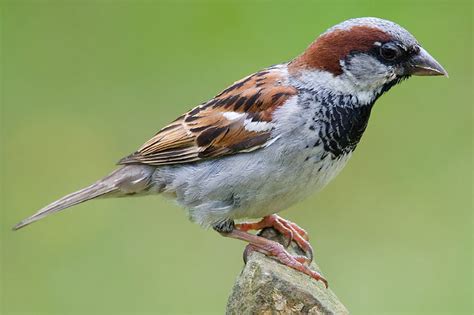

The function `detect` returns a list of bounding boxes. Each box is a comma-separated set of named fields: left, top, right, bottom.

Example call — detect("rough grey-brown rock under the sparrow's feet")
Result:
left=226, top=229, right=349, bottom=315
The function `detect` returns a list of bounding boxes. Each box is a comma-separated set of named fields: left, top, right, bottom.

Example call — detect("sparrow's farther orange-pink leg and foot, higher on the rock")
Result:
left=235, top=214, right=313, bottom=262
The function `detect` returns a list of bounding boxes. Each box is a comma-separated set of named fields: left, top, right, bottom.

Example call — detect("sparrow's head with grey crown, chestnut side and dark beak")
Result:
left=289, top=17, right=448, bottom=102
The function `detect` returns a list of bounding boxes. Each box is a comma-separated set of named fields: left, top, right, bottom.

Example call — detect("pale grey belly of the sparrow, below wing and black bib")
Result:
left=154, top=149, right=350, bottom=226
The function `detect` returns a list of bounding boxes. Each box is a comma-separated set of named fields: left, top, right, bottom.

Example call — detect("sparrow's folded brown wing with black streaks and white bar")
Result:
left=119, top=67, right=297, bottom=165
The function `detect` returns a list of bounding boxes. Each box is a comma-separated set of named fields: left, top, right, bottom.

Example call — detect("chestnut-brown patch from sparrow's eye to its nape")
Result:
left=288, top=26, right=391, bottom=75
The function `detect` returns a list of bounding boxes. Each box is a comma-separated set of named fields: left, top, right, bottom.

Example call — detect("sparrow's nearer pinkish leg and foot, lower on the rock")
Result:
left=214, top=221, right=328, bottom=288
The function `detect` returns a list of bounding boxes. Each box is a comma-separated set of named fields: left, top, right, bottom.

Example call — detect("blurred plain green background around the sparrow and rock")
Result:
left=0, top=0, right=473, bottom=314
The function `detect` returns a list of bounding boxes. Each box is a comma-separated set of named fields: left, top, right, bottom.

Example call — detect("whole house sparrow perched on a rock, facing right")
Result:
left=13, top=17, right=448, bottom=287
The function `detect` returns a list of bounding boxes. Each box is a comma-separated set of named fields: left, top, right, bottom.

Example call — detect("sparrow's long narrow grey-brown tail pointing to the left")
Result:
left=13, top=165, right=154, bottom=230
